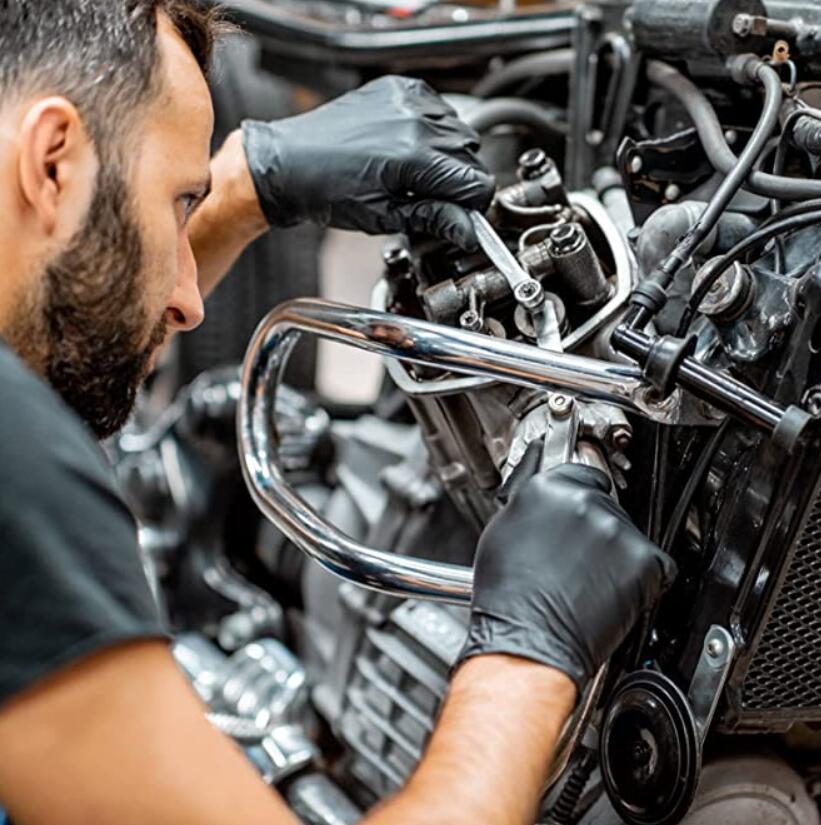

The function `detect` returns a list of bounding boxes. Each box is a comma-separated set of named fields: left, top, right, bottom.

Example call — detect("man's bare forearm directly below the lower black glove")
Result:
left=363, top=656, right=576, bottom=825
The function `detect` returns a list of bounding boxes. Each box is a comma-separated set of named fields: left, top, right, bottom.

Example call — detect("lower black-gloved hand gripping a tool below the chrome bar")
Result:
left=460, top=464, right=676, bottom=691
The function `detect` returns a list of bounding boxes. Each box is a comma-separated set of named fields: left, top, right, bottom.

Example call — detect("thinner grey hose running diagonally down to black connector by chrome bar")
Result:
left=627, top=63, right=784, bottom=329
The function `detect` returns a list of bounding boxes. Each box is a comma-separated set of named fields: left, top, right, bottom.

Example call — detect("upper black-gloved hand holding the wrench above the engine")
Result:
left=243, top=77, right=494, bottom=250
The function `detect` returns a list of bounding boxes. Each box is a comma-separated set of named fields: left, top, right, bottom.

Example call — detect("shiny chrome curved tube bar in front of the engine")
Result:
left=237, top=298, right=660, bottom=604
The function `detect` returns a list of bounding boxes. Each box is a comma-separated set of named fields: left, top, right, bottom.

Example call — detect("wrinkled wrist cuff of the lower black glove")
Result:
left=453, top=608, right=593, bottom=696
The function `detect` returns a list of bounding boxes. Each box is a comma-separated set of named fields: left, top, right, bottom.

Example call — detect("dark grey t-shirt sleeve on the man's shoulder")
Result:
left=0, top=348, right=165, bottom=703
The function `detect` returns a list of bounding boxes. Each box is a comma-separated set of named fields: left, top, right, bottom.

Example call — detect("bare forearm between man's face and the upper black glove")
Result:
left=189, top=131, right=268, bottom=297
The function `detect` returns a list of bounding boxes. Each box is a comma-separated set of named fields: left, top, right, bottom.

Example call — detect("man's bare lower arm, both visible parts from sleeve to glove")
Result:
left=0, top=642, right=575, bottom=825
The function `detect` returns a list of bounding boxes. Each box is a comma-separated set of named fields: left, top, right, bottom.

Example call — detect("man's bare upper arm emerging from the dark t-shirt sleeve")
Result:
left=0, top=641, right=297, bottom=825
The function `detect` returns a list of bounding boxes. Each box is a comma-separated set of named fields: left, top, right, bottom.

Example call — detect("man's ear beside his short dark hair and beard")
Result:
left=18, top=97, right=97, bottom=240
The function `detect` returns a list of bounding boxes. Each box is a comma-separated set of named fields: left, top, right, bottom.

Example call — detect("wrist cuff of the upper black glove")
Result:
left=242, top=120, right=305, bottom=228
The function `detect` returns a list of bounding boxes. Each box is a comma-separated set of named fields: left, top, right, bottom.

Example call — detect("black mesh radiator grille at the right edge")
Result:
left=742, top=495, right=821, bottom=711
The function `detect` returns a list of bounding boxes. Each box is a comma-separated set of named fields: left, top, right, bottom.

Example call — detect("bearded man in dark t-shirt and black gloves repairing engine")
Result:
left=0, top=0, right=673, bottom=825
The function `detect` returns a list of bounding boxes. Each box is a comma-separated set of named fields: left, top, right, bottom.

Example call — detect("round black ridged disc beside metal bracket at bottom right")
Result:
left=599, top=670, right=701, bottom=825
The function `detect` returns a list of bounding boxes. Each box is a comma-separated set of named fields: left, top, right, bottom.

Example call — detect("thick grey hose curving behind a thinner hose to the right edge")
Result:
left=647, top=60, right=821, bottom=201
